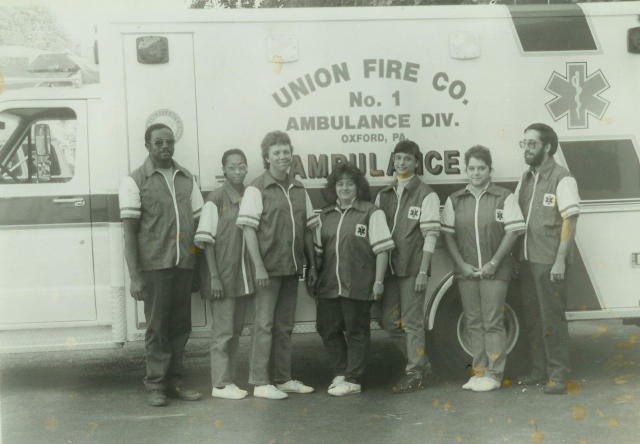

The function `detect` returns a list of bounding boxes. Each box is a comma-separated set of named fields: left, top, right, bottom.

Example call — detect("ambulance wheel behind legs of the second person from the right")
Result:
left=427, top=286, right=528, bottom=380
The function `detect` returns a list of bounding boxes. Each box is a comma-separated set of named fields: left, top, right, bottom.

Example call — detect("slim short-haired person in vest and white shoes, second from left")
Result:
left=195, top=149, right=253, bottom=399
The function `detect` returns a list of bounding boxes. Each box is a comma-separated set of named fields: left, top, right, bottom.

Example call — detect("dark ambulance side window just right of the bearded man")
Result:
left=561, top=139, right=640, bottom=200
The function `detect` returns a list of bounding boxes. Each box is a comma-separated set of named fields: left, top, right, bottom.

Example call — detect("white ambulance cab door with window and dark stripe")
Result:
left=0, top=101, right=96, bottom=329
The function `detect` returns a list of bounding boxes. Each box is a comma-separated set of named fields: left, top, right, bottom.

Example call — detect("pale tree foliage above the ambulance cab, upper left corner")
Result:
left=0, top=6, right=77, bottom=52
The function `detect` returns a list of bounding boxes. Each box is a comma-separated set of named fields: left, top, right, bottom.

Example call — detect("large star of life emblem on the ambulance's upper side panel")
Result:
left=544, top=62, right=609, bottom=129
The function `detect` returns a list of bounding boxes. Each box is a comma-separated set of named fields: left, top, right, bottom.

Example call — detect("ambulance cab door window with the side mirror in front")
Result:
left=0, top=108, right=77, bottom=183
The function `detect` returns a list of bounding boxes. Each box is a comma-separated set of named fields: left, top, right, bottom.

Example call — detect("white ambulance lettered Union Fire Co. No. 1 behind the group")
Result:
left=0, top=2, right=640, bottom=374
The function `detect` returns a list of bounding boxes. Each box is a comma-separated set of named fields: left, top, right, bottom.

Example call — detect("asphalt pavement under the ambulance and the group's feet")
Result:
left=0, top=321, right=640, bottom=444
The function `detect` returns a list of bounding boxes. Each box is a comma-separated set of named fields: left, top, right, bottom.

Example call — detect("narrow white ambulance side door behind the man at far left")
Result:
left=122, top=32, right=206, bottom=334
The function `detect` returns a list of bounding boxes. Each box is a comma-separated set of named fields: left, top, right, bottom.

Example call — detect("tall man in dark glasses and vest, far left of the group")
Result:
left=120, top=124, right=203, bottom=406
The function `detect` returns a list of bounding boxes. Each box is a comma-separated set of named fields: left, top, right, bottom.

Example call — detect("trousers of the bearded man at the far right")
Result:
left=520, top=261, right=570, bottom=382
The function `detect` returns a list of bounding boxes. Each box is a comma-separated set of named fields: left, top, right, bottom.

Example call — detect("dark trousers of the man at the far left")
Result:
left=143, top=268, right=193, bottom=390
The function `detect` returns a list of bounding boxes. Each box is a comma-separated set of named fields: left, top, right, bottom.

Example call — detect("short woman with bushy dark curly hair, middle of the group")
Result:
left=315, top=162, right=393, bottom=396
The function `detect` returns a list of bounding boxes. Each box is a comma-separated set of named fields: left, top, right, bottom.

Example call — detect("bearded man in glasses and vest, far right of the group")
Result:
left=515, top=123, right=580, bottom=394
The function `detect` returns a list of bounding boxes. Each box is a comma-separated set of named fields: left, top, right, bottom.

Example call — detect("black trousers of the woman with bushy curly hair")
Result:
left=316, top=297, right=371, bottom=382
